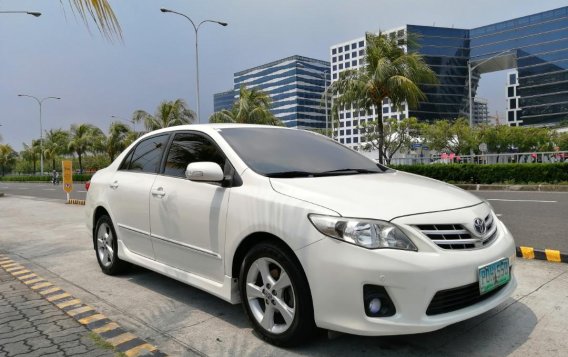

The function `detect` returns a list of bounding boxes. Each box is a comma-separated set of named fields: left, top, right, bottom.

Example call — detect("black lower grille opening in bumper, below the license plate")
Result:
left=426, top=283, right=508, bottom=316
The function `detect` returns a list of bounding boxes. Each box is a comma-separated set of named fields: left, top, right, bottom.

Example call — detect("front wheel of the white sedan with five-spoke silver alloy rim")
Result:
left=239, top=243, right=317, bottom=346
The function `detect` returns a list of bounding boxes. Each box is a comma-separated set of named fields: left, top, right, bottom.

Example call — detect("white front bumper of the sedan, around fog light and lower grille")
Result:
left=296, top=218, right=517, bottom=336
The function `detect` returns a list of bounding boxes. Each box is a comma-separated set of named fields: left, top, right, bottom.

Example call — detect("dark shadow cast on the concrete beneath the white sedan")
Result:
left=116, top=266, right=537, bottom=356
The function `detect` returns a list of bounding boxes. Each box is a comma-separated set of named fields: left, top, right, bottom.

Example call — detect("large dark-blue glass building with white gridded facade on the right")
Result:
left=330, top=6, right=568, bottom=146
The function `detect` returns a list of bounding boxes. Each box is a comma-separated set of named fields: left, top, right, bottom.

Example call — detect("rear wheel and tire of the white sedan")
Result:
left=95, top=215, right=127, bottom=275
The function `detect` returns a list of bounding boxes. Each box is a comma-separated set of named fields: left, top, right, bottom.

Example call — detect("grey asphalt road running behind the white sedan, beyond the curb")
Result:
left=0, top=182, right=568, bottom=253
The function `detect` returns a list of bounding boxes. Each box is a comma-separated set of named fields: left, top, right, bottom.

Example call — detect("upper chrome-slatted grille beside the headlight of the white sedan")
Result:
left=416, top=214, right=497, bottom=249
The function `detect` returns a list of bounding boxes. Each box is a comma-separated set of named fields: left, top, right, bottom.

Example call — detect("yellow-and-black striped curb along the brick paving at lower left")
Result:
left=0, top=255, right=167, bottom=357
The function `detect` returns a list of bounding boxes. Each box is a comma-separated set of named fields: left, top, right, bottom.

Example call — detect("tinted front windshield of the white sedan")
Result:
left=219, top=127, right=387, bottom=177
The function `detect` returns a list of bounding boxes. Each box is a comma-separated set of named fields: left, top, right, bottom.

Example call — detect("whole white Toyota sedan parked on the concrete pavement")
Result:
left=85, top=125, right=517, bottom=346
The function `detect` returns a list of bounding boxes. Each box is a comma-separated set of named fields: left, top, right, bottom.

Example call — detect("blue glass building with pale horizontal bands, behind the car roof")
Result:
left=214, top=56, right=331, bottom=129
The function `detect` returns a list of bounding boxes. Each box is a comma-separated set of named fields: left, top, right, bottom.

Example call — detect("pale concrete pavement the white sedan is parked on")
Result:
left=0, top=196, right=568, bottom=357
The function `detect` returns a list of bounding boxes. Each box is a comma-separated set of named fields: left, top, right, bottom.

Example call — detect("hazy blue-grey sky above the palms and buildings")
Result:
left=0, top=0, right=566, bottom=150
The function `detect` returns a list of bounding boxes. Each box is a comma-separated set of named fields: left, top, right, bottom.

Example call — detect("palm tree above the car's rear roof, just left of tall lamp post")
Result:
left=132, top=98, right=195, bottom=131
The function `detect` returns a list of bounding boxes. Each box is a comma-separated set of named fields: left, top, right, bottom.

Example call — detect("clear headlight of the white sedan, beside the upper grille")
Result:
left=308, top=214, right=418, bottom=251
